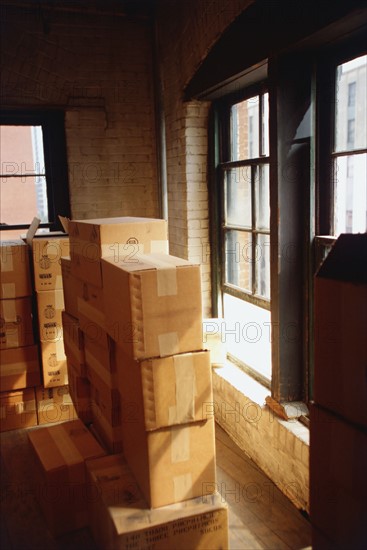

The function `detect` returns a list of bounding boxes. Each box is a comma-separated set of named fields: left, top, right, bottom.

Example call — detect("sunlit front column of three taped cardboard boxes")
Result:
left=102, top=254, right=215, bottom=508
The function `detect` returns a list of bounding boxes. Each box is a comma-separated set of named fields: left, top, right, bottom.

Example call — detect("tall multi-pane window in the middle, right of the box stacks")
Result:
left=217, top=90, right=271, bottom=387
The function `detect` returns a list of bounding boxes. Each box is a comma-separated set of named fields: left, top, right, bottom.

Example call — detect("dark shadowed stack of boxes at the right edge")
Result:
left=310, top=234, right=367, bottom=550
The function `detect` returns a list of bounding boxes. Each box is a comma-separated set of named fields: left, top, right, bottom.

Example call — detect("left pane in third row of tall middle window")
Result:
left=224, top=230, right=252, bottom=292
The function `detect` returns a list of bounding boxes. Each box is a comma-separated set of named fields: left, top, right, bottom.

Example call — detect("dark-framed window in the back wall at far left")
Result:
left=0, top=112, right=70, bottom=239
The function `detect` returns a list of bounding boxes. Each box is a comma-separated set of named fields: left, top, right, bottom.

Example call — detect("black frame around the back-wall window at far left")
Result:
left=0, top=109, right=70, bottom=234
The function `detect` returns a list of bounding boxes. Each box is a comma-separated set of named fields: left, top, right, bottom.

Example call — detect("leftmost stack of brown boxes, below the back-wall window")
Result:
left=0, top=244, right=41, bottom=431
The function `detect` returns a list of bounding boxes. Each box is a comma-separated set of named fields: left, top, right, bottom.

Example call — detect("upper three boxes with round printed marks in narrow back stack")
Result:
left=31, top=235, right=69, bottom=388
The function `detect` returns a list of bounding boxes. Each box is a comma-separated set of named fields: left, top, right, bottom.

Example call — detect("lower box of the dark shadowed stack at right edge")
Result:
left=310, top=404, right=367, bottom=549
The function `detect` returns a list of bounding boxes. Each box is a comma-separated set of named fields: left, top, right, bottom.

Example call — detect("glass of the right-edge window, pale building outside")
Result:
left=332, top=55, right=367, bottom=236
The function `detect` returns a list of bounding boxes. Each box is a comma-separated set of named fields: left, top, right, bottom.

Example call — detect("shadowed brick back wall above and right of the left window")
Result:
left=1, top=7, right=159, bottom=218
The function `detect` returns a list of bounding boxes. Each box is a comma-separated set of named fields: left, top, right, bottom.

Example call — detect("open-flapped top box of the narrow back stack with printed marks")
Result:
left=32, top=235, right=70, bottom=292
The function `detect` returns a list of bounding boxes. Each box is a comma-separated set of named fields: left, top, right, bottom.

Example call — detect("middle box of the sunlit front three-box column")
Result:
left=114, top=346, right=213, bottom=430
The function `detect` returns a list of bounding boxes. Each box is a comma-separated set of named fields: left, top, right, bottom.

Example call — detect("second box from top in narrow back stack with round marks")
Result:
left=37, top=289, right=64, bottom=342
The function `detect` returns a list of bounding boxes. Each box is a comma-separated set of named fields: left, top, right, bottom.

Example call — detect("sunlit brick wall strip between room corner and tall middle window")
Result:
left=157, top=0, right=251, bottom=316
